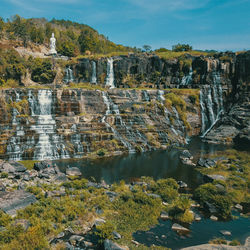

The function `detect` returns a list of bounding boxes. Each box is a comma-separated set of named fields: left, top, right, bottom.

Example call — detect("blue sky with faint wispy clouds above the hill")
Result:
left=0, top=0, right=250, bottom=50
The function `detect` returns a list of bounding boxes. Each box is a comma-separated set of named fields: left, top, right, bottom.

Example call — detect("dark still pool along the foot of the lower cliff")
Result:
left=55, top=138, right=229, bottom=189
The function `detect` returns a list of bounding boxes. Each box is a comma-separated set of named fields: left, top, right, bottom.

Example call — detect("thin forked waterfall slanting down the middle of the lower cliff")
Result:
left=102, top=91, right=135, bottom=154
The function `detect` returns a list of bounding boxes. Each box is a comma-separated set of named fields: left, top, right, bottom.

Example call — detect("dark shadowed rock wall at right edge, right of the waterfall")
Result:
left=206, top=51, right=250, bottom=147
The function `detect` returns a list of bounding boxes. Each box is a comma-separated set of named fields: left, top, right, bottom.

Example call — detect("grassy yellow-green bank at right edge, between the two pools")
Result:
left=194, top=150, right=250, bottom=218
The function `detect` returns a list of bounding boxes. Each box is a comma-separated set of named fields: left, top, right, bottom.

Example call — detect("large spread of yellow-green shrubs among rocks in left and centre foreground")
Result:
left=0, top=177, right=195, bottom=249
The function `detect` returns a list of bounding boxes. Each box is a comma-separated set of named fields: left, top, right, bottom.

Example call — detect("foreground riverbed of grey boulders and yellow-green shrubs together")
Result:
left=0, top=151, right=247, bottom=249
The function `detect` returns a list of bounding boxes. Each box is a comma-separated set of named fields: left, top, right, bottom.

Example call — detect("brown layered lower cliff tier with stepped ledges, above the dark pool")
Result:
left=0, top=89, right=200, bottom=160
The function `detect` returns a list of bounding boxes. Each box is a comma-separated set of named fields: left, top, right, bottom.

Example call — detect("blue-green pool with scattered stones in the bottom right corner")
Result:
left=133, top=211, right=250, bottom=250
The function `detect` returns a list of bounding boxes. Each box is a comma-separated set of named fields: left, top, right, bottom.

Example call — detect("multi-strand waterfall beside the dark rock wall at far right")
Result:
left=200, top=73, right=223, bottom=138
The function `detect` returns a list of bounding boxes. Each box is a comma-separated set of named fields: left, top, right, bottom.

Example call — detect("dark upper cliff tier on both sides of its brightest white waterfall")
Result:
left=74, top=53, right=236, bottom=88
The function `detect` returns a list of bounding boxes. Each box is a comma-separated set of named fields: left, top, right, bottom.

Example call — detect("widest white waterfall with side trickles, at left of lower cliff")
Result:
left=7, top=89, right=69, bottom=161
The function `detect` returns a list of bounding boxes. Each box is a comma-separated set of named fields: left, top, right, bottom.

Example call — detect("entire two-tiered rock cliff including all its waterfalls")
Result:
left=0, top=52, right=250, bottom=160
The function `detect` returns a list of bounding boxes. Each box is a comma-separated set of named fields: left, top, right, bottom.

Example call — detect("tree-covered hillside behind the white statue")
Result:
left=0, top=15, right=137, bottom=57
